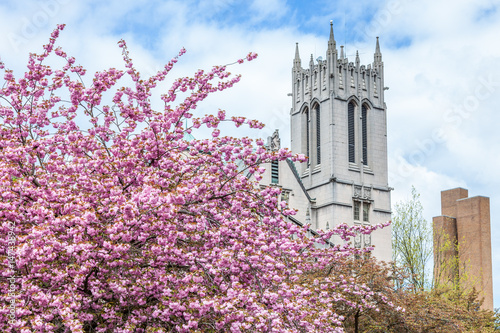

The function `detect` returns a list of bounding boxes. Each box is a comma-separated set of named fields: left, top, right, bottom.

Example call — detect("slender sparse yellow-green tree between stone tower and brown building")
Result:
left=392, top=186, right=432, bottom=290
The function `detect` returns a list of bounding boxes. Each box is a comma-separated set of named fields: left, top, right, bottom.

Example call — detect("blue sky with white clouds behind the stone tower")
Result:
left=0, top=0, right=500, bottom=307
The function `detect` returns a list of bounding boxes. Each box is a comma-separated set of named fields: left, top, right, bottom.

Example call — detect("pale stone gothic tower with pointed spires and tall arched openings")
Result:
left=291, top=22, right=392, bottom=261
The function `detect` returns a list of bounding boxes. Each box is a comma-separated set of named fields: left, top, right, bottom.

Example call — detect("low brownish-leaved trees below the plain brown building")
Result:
left=323, top=256, right=498, bottom=333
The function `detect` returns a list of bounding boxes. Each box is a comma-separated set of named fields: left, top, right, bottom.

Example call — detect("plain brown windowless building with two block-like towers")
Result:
left=433, top=188, right=493, bottom=310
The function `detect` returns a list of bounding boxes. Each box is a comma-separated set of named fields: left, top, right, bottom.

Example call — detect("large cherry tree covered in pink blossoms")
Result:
left=0, top=25, right=388, bottom=332
